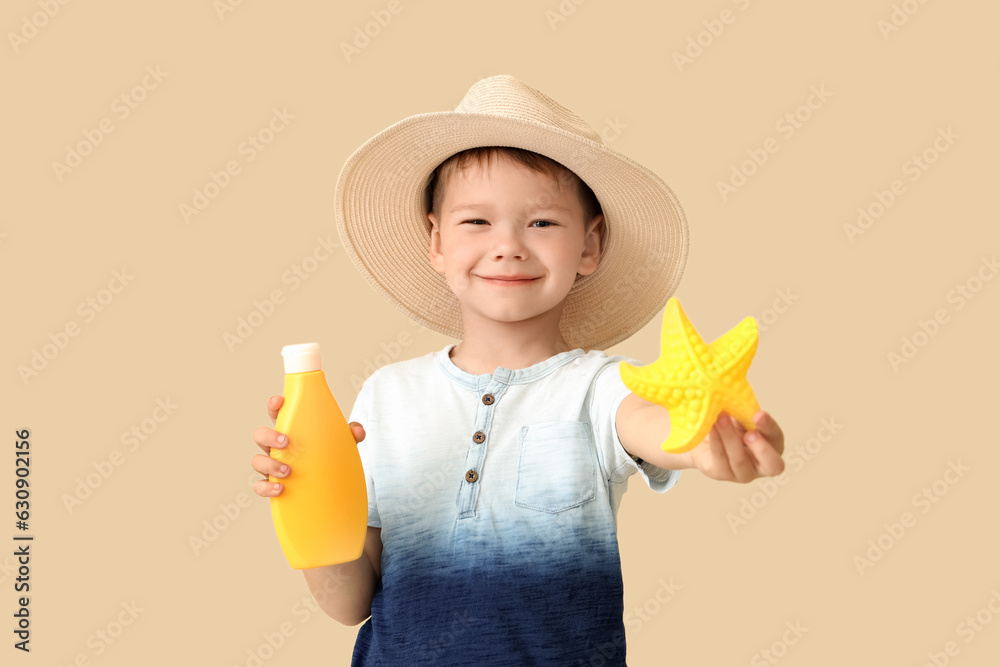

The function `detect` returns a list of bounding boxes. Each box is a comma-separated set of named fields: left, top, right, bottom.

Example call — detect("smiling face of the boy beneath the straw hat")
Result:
left=428, top=158, right=603, bottom=334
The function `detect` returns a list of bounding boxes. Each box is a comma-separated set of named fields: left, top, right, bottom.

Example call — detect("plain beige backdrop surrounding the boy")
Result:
left=0, top=0, right=1000, bottom=667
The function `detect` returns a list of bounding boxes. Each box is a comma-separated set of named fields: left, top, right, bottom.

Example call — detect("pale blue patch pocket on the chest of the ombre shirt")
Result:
left=514, top=421, right=597, bottom=513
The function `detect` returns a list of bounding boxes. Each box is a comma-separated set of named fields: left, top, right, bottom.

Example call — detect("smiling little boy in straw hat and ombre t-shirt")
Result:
left=252, top=76, right=783, bottom=666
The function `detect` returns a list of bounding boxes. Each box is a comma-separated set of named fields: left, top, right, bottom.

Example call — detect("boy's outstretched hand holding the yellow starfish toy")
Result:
left=688, top=410, right=785, bottom=484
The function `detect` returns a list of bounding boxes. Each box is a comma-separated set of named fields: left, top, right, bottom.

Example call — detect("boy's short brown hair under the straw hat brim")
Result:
left=424, top=146, right=606, bottom=234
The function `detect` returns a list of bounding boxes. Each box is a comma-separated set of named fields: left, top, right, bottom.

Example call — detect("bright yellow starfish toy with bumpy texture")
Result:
left=619, top=298, right=760, bottom=454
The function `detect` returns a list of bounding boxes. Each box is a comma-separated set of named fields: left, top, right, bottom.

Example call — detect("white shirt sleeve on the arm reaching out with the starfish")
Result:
left=590, top=355, right=681, bottom=493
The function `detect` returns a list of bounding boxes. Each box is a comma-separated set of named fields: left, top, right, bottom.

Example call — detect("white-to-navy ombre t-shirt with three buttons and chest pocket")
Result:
left=350, top=345, right=680, bottom=667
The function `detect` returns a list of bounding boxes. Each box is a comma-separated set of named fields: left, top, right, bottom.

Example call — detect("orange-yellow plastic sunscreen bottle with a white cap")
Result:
left=270, top=343, right=368, bottom=570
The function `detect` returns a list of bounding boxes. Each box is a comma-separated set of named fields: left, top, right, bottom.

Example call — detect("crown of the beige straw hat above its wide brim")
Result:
left=455, top=74, right=604, bottom=144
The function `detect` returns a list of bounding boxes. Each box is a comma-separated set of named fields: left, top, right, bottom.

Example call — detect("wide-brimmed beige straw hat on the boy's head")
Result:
left=335, top=75, right=688, bottom=350
